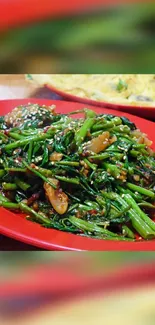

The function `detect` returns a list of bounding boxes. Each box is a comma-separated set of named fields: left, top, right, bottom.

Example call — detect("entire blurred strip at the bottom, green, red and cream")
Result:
left=0, top=252, right=155, bottom=325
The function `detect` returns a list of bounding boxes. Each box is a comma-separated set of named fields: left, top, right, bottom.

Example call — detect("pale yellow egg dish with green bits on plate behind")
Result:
left=28, top=74, right=155, bottom=106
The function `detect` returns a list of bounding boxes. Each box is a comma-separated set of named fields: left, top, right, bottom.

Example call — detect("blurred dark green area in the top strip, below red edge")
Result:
left=0, top=2, right=155, bottom=73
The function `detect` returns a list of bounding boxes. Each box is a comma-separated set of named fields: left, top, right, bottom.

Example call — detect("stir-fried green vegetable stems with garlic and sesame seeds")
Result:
left=0, top=104, right=155, bottom=241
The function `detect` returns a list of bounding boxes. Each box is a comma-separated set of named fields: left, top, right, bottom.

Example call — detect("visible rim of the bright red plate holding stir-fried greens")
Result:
left=0, top=99, right=155, bottom=251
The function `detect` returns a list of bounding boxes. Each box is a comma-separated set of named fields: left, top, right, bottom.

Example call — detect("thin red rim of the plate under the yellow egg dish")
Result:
left=46, top=85, right=155, bottom=121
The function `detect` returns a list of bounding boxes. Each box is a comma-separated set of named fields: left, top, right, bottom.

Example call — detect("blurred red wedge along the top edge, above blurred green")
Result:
left=0, top=0, right=151, bottom=31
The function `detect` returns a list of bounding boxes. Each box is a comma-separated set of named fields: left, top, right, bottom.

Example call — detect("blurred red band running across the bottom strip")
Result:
left=0, top=256, right=155, bottom=300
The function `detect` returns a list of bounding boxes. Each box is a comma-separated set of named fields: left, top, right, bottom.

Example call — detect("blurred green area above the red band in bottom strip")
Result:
left=0, top=252, right=155, bottom=280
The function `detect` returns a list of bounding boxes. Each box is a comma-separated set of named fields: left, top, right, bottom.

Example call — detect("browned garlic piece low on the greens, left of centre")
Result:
left=44, top=178, right=68, bottom=214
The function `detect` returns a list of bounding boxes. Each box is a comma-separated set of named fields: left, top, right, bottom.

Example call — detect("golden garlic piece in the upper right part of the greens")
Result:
left=84, top=132, right=110, bottom=153
